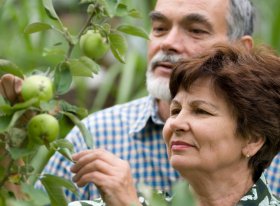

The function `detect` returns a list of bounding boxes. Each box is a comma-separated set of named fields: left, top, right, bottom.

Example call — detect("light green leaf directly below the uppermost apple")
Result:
left=69, top=56, right=100, bottom=77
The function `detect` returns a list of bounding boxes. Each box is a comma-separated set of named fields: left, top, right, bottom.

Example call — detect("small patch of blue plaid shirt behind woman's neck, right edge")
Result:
left=265, top=153, right=280, bottom=197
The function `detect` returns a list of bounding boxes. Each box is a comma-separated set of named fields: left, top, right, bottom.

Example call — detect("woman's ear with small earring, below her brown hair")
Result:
left=242, top=137, right=265, bottom=157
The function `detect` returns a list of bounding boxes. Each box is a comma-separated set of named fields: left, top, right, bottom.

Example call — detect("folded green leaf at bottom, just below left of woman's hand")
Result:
left=41, top=174, right=77, bottom=206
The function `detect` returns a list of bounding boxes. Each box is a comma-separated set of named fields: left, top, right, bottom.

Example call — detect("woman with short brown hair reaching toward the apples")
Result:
left=69, top=44, right=280, bottom=206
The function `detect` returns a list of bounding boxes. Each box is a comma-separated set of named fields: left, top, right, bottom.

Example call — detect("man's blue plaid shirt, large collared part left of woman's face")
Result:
left=36, top=97, right=179, bottom=201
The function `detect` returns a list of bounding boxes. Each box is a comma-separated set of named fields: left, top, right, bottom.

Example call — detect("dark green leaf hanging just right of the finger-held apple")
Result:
left=54, top=62, right=72, bottom=95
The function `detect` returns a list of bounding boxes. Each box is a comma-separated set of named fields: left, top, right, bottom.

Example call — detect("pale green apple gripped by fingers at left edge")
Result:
left=21, top=75, right=53, bottom=104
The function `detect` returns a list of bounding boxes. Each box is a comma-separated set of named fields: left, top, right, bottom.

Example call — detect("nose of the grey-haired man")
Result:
left=161, top=28, right=184, bottom=54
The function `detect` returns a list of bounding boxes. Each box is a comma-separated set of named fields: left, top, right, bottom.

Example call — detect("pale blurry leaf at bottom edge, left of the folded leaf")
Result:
left=21, top=184, right=50, bottom=206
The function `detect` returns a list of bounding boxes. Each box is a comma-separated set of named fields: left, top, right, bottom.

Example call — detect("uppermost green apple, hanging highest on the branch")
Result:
left=80, top=30, right=110, bottom=60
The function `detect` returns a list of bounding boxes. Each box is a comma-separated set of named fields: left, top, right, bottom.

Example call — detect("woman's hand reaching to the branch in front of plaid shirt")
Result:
left=71, top=149, right=140, bottom=206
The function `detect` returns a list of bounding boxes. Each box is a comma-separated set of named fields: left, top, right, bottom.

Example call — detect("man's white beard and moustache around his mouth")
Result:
left=146, top=51, right=182, bottom=101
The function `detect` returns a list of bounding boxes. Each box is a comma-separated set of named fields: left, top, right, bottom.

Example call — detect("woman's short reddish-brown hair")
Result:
left=170, top=44, right=280, bottom=182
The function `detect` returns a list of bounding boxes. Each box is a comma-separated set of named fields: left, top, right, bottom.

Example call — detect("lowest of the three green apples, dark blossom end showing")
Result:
left=27, top=114, right=59, bottom=145
